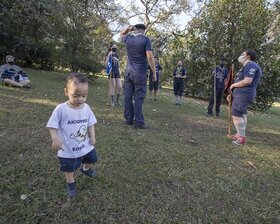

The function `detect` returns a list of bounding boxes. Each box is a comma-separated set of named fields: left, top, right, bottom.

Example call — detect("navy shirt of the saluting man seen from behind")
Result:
left=122, top=34, right=152, bottom=75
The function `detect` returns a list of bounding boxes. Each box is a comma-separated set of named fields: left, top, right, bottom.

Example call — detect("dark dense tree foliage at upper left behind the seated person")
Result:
left=0, top=0, right=121, bottom=72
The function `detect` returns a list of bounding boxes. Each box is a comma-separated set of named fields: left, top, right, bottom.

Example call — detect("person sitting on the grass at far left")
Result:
left=0, top=55, right=31, bottom=88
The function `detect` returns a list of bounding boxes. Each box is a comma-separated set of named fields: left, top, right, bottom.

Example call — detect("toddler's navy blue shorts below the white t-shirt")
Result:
left=58, top=149, right=98, bottom=172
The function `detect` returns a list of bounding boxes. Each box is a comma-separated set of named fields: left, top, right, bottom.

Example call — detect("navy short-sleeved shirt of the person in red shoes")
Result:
left=233, top=61, right=262, bottom=98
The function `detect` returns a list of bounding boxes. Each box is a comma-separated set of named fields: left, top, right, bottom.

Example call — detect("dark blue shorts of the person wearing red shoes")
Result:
left=232, top=95, right=252, bottom=117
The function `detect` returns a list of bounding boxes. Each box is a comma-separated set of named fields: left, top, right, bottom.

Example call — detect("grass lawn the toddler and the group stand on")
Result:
left=0, top=70, right=280, bottom=224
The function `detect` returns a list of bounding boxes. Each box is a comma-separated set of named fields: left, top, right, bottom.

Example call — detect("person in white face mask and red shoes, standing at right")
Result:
left=228, top=49, right=262, bottom=145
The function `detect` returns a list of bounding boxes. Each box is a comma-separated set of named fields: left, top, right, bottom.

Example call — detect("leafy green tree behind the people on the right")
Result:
left=161, top=0, right=279, bottom=109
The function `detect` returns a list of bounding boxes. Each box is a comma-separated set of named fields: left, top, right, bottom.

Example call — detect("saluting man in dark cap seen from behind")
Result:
left=121, top=24, right=157, bottom=129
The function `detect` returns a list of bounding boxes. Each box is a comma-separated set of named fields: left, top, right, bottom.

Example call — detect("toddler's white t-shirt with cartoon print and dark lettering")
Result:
left=47, top=102, right=97, bottom=158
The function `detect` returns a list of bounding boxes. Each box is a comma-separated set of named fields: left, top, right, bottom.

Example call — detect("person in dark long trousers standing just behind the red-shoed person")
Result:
left=207, top=58, right=228, bottom=117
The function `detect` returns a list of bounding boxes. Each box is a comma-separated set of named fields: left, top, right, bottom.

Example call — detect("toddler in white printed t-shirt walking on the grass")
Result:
left=47, top=73, right=97, bottom=197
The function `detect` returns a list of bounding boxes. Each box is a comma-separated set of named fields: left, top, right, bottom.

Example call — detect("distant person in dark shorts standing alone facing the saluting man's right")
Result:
left=173, top=61, right=187, bottom=106
